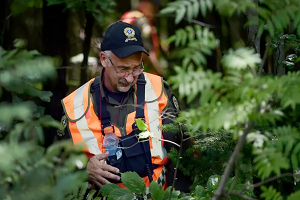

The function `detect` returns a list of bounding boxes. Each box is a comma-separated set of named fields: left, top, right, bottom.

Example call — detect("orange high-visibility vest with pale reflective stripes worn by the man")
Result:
left=62, top=72, right=168, bottom=189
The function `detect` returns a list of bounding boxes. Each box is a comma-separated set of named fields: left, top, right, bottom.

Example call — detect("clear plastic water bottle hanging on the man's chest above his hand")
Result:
left=103, top=132, right=119, bottom=161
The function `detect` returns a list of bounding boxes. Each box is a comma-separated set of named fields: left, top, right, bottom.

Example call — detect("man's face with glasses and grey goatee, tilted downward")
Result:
left=100, top=52, right=142, bottom=92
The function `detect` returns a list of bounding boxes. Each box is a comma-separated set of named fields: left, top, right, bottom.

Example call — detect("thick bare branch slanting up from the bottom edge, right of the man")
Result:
left=212, top=123, right=253, bottom=200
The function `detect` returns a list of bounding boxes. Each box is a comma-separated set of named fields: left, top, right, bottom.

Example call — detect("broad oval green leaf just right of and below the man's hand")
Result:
left=121, top=172, right=146, bottom=194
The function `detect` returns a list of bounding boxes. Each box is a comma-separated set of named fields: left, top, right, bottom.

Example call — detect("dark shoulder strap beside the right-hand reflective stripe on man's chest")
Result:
left=135, top=73, right=146, bottom=119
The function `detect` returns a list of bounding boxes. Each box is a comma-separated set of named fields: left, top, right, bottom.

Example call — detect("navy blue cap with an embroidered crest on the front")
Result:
left=101, top=21, right=149, bottom=58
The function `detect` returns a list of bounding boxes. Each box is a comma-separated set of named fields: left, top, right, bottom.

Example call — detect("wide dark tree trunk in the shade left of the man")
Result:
left=43, top=0, right=69, bottom=146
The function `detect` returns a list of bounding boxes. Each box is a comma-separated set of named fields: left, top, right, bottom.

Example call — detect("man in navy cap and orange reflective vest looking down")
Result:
left=59, top=21, right=190, bottom=196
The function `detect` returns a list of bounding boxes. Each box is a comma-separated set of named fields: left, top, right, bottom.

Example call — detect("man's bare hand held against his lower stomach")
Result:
left=86, top=152, right=120, bottom=187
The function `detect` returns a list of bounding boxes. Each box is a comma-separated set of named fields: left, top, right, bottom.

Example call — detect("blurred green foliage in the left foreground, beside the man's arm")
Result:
left=0, top=43, right=86, bottom=200
